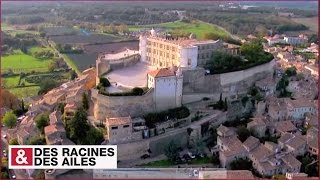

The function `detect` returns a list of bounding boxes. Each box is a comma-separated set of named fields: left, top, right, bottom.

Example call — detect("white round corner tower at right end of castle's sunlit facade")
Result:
left=178, top=46, right=198, bottom=69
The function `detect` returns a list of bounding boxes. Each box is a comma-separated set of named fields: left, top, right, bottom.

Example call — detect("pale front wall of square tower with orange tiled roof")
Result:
left=154, top=76, right=177, bottom=111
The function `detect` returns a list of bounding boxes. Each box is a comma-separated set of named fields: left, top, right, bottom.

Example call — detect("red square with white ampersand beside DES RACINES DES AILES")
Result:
left=11, top=148, right=33, bottom=166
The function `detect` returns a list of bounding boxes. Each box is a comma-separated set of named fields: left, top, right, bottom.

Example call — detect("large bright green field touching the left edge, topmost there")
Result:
left=1, top=51, right=51, bottom=73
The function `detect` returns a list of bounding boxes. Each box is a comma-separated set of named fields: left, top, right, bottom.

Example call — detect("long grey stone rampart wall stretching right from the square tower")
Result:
left=183, top=60, right=275, bottom=103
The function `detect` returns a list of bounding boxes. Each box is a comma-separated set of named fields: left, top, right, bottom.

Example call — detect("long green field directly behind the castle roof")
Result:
left=129, top=21, right=229, bottom=39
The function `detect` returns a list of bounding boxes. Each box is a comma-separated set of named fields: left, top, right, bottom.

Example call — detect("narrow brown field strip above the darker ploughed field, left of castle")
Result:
left=51, top=34, right=123, bottom=44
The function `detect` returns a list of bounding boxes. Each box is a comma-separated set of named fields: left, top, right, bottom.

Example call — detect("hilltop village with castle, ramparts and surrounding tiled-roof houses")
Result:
left=2, top=29, right=318, bottom=178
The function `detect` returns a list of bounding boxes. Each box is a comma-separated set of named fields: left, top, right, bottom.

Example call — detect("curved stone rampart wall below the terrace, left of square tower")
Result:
left=91, top=89, right=155, bottom=120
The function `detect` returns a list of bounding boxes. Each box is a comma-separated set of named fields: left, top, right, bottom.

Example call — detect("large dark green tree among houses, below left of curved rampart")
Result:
left=67, top=107, right=90, bottom=144
